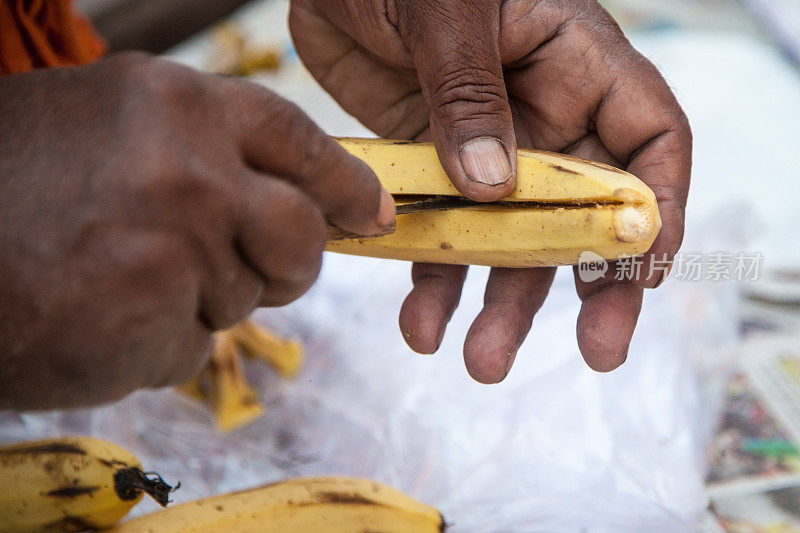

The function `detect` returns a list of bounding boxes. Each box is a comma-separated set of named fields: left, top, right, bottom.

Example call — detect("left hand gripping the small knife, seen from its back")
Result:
left=0, top=54, right=394, bottom=409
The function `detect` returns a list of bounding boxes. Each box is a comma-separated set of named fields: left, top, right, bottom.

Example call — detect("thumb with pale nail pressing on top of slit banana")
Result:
left=397, top=0, right=516, bottom=201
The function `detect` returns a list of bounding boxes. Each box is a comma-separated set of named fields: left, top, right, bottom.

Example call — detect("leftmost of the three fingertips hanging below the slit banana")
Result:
left=400, top=263, right=467, bottom=354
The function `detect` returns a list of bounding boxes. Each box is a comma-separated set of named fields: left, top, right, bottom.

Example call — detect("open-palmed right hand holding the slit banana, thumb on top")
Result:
left=289, top=0, right=692, bottom=383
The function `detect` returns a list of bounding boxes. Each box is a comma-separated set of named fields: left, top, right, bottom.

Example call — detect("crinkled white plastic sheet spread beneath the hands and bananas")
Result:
left=0, top=254, right=728, bottom=532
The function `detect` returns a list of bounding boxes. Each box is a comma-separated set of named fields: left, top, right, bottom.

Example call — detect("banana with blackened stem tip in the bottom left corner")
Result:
left=0, top=437, right=173, bottom=533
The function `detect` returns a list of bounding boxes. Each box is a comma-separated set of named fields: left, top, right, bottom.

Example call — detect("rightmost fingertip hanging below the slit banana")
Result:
left=574, top=268, right=644, bottom=372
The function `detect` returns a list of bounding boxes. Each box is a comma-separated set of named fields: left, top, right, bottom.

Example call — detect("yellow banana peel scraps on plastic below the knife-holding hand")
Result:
left=178, top=320, right=303, bottom=432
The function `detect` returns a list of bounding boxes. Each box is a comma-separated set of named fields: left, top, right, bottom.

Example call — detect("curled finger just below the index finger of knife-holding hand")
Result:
left=236, top=172, right=327, bottom=306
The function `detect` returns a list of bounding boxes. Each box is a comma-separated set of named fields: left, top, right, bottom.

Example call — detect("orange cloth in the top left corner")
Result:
left=0, top=0, right=105, bottom=76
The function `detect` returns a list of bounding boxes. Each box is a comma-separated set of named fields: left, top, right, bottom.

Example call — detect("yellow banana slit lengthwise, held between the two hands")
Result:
left=326, top=138, right=661, bottom=267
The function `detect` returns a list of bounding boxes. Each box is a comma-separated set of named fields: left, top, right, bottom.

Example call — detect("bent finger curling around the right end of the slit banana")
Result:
left=595, top=53, right=692, bottom=288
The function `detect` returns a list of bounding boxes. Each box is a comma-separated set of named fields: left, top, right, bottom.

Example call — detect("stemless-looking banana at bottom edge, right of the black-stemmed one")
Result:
left=111, top=478, right=445, bottom=533
